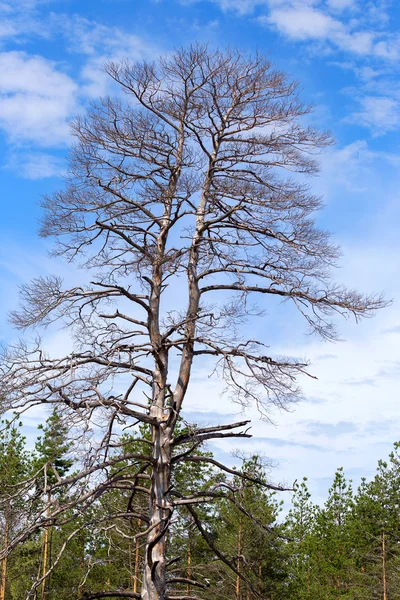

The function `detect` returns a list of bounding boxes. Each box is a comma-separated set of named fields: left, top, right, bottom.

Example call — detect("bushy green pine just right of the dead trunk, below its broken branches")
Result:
left=205, top=456, right=286, bottom=600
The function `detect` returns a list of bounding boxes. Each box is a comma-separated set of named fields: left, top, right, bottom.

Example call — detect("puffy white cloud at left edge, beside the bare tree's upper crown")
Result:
left=0, top=51, right=78, bottom=147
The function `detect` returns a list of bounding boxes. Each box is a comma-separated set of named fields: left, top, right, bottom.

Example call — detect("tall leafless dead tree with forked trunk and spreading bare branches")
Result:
left=0, top=45, right=384, bottom=600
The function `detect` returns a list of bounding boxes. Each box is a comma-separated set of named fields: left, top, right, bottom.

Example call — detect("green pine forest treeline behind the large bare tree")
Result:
left=0, top=411, right=400, bottom=600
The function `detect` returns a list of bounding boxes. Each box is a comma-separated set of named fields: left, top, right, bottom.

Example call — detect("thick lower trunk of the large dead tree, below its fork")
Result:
left=142, top=418, right=171, bottom=600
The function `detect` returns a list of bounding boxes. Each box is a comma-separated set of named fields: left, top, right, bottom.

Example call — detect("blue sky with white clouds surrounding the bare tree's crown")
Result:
left=0, top=0, right=400, bottom=504
